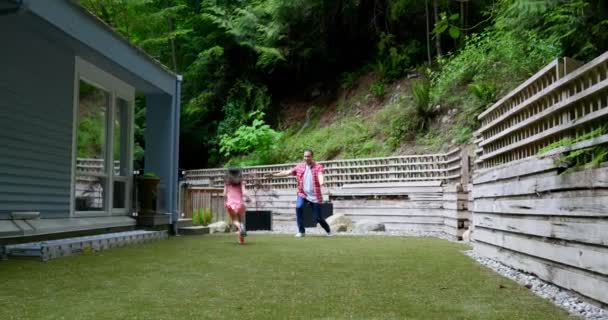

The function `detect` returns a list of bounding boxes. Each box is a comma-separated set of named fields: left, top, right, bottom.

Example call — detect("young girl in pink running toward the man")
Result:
left=224, top=168, right=247, bottom=244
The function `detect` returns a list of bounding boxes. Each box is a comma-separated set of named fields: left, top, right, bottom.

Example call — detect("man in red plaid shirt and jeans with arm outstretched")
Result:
left=269, top=149, right=331, bottom=238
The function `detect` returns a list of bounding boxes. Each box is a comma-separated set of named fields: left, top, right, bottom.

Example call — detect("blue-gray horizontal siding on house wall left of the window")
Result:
left=0, top=15, right=74, bottom=219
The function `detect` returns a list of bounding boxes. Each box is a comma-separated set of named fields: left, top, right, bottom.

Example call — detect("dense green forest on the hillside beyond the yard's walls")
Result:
left=80, top=0, right=608, bottom=169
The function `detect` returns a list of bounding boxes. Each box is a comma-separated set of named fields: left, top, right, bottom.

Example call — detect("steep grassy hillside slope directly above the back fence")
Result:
left=278, top=73, right=457, bottom=160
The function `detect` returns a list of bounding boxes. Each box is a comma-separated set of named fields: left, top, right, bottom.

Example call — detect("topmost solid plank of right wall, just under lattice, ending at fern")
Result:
left=473, top=157, right=557, bottom=184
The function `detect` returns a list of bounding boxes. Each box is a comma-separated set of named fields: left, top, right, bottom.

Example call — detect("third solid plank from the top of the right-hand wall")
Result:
left=473, top=190, right=608, bottom=217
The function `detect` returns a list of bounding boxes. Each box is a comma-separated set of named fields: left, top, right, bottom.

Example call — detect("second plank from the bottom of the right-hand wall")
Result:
left=475, top=225, right=608, bottom=275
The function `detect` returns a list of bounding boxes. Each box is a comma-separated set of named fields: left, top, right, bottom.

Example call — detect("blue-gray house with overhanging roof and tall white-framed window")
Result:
left=0, top=0, right=181, bottom=249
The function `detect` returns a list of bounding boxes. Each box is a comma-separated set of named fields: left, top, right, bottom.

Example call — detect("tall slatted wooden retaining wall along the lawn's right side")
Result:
left=471, top=53, right=608, bottom=303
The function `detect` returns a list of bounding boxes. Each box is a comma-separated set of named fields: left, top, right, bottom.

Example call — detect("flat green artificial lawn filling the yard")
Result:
left=0, top=234, right=569, bottom=320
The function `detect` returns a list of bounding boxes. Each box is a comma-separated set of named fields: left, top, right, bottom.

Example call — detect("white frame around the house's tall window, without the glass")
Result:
left=70, top=56, right=135, bottom=217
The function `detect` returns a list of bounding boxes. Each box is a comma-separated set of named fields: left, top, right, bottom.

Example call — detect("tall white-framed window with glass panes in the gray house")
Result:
left=72, top=58, right=134, bottom=216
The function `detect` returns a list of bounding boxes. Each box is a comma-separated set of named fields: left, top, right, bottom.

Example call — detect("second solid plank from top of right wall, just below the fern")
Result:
left=473, top=168, right=608, bottom=199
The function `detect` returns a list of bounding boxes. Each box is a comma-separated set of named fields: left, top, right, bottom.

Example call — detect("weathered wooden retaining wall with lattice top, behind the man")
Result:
left=185, top=149, right=469, bottom=238
